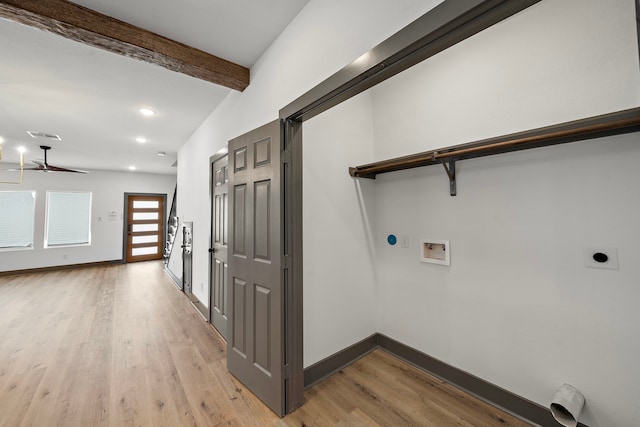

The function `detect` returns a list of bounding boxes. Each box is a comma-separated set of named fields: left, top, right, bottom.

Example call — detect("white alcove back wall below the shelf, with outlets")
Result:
left=375, top=138, right=640, bottom=427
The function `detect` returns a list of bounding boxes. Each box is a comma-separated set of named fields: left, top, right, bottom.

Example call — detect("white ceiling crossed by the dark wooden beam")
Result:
left=0, top=0, right=308, bottom=179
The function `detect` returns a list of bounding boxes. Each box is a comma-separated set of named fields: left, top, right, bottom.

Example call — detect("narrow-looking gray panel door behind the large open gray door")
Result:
left=209, top=156, right=229, bottom=339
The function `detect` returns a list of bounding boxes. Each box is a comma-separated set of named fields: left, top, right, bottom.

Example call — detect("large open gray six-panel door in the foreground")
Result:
left=227, top=121, right=285, bottom=416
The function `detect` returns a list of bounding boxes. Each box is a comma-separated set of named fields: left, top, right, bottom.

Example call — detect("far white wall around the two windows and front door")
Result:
left=0, top=171, right=176, bottom=271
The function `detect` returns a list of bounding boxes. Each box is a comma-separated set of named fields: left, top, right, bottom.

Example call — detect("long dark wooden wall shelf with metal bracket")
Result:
left=349, top=107, right=640, bottom=196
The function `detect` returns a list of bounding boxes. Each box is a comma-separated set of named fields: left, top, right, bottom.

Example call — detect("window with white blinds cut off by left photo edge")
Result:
left=0, top=191, right=36, bottom=250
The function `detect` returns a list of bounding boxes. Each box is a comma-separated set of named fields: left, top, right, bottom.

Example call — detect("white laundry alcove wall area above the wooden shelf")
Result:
left=373, top=0, right=640, bottom=159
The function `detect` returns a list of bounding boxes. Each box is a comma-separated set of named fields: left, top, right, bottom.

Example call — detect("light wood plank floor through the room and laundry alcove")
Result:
left=0, top=262, right=528, bottom=427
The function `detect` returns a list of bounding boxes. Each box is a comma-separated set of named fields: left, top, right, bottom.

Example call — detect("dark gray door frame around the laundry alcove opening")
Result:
left=279, top=0, right=540, bottom=413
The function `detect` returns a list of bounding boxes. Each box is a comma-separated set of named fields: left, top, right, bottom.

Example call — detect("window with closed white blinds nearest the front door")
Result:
left=44, top=191, right=91, bottom=248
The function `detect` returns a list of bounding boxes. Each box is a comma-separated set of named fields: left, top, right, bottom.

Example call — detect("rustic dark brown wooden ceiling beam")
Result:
left=0, top=0, right=249, bottom=91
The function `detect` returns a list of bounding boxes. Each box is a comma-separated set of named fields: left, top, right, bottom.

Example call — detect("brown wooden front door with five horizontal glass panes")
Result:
left=125, top=194, right=166, bottom=262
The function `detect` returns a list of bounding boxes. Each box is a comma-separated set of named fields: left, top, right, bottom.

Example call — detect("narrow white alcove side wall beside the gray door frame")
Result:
left=302, top=93, right=377, bottom=366
